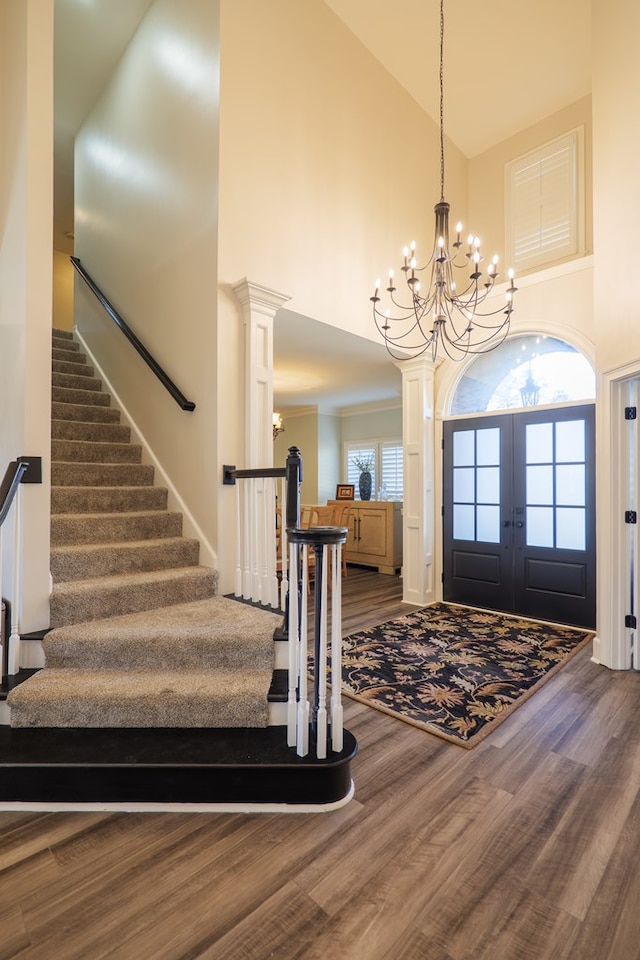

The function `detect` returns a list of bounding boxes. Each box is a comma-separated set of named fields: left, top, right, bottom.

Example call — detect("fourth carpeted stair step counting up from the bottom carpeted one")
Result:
left=50, top=537, right=200, bottom=583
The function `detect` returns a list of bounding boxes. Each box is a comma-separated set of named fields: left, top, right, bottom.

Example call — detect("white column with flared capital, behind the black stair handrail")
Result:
left=233, top=277, right=291, bottom=469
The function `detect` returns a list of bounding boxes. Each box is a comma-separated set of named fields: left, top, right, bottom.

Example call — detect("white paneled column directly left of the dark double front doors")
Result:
left=397, top=357, right=436, bottom=605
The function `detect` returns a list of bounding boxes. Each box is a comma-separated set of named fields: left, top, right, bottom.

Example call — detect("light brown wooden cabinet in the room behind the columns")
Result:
left=329, top=500, right=402, bottom=574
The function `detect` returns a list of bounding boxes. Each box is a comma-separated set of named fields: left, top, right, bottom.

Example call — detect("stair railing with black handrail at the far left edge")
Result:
left=0, top=458, right=29, bottom=684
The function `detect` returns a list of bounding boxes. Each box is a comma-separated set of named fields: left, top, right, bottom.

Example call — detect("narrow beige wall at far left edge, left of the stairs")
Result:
left=0, top=0, right=53, bottom=632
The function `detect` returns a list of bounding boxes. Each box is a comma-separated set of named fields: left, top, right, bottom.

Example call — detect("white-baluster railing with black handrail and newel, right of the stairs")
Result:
left=223, top=447, right=347, bottom=759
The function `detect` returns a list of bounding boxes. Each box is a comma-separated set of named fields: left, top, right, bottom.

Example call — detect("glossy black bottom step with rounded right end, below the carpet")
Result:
left=0, top=727, right=357, bottom=806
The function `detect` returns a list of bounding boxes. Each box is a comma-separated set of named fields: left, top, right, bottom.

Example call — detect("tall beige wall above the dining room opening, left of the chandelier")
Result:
left=220, top=0, right=467, bottom=339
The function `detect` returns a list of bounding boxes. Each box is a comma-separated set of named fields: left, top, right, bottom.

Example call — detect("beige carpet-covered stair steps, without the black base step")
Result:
left=9, top=331, right=279, bottom=728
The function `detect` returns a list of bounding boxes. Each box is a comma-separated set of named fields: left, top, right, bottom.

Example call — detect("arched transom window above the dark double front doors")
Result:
left=450, top=334, right=596, bottom=416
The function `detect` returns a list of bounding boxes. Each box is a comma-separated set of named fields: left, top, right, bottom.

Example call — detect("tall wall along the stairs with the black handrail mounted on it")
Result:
left=75, top=0, right=220, bottom=559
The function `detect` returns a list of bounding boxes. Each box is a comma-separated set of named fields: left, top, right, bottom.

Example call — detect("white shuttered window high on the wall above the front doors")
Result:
left=505, top=127, right=584, bottom=273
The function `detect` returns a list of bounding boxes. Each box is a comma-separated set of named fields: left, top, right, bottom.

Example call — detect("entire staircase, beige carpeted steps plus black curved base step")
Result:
left=0, top=331, right=357, bottom=810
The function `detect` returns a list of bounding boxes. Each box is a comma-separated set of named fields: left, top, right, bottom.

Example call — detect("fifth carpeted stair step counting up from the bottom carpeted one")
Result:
left=51, top=510, right=182, bottom=547
